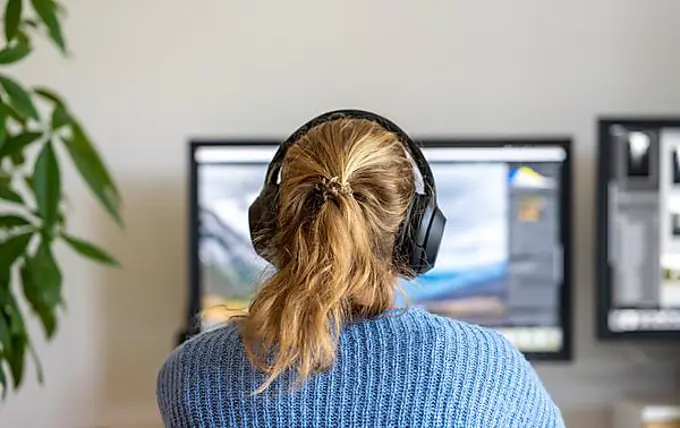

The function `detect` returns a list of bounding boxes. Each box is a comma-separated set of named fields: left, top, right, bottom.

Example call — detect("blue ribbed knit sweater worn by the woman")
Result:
left=158, top=309, right=564, bottom=428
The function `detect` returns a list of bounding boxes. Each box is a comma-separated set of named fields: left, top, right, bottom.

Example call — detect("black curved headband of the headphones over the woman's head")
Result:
left=265, top=109, right=436, bottom=197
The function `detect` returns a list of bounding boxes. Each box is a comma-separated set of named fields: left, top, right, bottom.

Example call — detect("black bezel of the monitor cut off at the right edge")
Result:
left=595, top=116, right=680, bottom=342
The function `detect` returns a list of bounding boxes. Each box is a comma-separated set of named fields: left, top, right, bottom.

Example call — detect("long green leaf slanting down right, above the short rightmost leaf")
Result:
left=64, top=121, right=123, bottom=227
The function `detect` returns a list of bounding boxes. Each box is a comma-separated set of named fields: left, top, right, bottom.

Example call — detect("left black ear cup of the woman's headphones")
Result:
left=248, top=184, right=279, bottom=263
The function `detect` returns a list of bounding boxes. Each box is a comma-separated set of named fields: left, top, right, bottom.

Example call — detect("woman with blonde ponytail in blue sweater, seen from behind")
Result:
left=158, top=112, right=564, bottom=428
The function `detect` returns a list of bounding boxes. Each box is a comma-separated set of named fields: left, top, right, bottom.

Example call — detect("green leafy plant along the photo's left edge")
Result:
left=0, top=0, right=123, bottom=398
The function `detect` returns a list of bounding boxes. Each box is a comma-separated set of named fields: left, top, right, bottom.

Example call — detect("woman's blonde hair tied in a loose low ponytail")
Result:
left=237, top=119, right=415, bottom=393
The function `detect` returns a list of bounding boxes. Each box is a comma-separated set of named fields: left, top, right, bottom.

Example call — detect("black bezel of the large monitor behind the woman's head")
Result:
left=186, top=136, right=573, bottom=362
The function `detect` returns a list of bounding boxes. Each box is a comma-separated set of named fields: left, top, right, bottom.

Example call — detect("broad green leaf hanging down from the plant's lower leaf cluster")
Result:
left=26, top=239, right=62, bottom=308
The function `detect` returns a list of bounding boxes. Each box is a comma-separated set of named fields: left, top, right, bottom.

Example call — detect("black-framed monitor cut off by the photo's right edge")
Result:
left=597, top=117, right=680, bottom=340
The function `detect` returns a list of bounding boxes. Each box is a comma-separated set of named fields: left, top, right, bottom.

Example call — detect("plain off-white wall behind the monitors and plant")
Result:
left=0, top=0, right=680, bottom=428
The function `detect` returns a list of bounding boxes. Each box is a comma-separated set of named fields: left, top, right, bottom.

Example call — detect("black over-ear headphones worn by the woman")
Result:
left=248, top=110, right=446, bottom=276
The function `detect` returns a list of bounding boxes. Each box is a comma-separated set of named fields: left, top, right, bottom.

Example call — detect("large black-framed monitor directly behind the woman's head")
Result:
left=189, top=139, right=571, bottom=360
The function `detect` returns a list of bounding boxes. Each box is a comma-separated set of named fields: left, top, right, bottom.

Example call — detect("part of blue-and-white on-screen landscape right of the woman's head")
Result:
left=398, top=163, right=510, bottom=325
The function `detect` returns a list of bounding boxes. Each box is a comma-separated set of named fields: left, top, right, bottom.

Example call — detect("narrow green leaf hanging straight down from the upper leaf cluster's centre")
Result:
left=33, top=141, right=61, bottom=231
